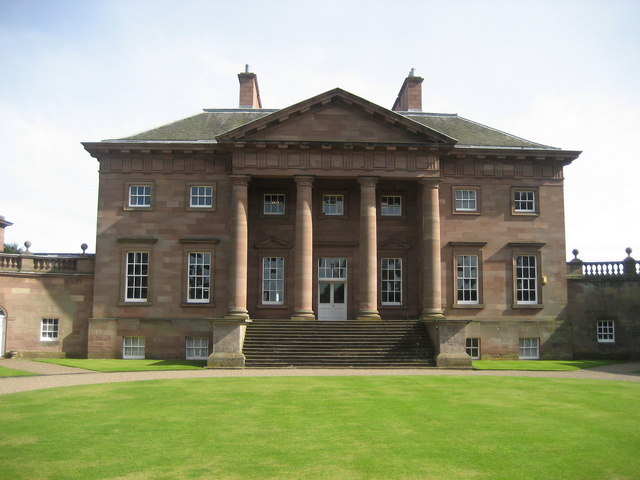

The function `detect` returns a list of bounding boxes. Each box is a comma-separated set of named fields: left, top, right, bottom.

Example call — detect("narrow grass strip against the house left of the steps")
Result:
left=34, top=358, right=207, bottom=372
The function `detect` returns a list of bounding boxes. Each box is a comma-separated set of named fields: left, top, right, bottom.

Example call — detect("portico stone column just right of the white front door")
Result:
left=358, top=177, right=380, bottom=320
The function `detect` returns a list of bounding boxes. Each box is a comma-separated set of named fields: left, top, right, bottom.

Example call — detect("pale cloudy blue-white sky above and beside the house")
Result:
left=0, top=0, right=640, bottom=261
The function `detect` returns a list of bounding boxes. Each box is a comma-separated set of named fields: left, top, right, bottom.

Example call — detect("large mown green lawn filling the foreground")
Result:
left=0, top=376, right=640, bottom=480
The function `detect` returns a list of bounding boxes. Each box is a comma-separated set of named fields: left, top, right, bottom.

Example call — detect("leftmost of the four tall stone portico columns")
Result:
left=226, top=175, right=251, bottom=319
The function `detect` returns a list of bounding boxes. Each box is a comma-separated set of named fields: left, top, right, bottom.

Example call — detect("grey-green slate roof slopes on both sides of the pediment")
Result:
left=118, top=109, right=559, bottom=150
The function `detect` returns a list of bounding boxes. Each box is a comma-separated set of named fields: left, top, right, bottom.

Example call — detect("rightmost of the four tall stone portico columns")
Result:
left=421, top=178, right=444, bottom=320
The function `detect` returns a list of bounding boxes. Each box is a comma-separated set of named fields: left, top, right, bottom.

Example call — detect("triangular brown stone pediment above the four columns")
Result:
left=217, top=88, right=456, bottom=146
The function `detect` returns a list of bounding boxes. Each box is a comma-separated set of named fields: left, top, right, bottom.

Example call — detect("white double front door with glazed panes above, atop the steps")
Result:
left=318, top=257, right=347, bottom=320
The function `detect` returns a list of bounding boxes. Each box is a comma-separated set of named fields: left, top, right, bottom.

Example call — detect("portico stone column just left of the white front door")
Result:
left=291, top=176, right=315, bottom=320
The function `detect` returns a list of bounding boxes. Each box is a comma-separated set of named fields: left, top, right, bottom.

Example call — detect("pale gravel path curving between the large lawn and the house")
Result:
left=0, top=359, right=640, bottom=394
